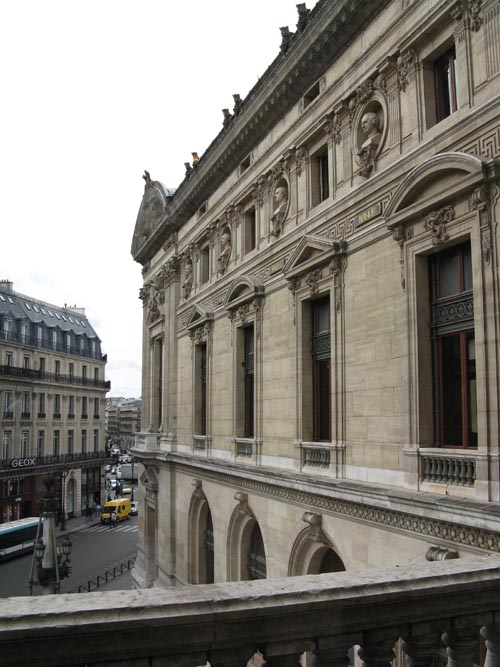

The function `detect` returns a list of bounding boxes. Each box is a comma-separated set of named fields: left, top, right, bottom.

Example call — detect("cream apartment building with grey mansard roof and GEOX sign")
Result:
left=0, top=280, right=110, bottom=522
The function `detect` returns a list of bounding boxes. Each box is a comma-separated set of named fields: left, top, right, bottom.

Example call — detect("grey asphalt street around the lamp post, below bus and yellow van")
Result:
left=0, top=516, right=138, bottom=597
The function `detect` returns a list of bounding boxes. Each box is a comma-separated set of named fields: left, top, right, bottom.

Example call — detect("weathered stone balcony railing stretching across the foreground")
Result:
left=0, top=555, right=500, bottom=667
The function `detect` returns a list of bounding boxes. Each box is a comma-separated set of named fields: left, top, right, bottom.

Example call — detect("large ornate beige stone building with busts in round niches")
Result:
left=132, top=0, right=500, bottom=587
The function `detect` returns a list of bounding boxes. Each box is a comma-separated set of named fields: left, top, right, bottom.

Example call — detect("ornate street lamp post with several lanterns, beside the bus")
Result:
left=29, top=476, right=72, bottom=595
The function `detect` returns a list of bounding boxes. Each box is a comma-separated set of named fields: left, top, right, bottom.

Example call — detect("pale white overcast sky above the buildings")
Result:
left=0, top=0, right=300, bottom=397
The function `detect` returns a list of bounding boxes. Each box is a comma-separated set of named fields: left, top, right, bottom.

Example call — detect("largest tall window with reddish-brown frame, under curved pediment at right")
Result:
left=430, top=243, right=477, bottom=447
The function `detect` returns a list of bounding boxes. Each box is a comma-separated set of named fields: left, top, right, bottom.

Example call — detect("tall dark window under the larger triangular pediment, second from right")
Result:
left=311, top=297, right=332, bottom=442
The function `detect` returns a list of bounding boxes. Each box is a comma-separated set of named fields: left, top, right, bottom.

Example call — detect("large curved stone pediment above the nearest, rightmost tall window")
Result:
left=384, top=153, right=487, bottom=229
